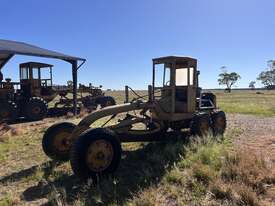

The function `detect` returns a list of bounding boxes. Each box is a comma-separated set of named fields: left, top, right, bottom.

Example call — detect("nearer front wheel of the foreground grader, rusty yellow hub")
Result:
left=70, top=128, right=121, bottom=179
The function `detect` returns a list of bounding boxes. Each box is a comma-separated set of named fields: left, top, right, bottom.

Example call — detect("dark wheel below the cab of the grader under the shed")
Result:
left=24, top=97, right=48, bottom=121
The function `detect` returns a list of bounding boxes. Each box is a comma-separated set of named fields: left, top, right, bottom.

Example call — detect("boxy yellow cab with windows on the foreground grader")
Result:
left=152, top=57, right=204, bottom=121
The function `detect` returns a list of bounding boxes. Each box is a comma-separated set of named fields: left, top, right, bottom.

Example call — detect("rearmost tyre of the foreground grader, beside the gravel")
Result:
left=211, top=111, right=226, bottom=136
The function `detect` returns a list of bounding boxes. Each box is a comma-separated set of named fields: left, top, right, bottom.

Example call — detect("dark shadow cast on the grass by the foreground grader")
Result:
left=17, top=133, right=190, bottom=205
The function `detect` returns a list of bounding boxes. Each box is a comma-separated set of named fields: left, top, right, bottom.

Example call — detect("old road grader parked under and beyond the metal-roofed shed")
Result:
left=0, top=62, right=115, bottom=121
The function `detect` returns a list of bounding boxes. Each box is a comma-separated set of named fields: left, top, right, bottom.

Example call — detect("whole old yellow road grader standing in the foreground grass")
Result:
left=42, top=56, right=226, bottom=179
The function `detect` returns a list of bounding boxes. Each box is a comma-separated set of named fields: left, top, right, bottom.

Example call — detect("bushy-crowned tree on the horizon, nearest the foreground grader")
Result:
left=218, top=66, right=241, bottom=92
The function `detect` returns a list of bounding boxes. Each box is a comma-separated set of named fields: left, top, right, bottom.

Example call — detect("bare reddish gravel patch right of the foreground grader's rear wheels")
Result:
left=228, top=114, right=275, bottom=206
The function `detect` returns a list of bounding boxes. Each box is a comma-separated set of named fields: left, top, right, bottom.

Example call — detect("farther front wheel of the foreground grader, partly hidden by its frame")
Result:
left=42, top=122, right=75, bottom=161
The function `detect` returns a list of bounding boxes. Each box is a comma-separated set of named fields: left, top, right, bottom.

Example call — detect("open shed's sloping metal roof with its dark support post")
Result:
left=0, top=39, right=86, bottom=114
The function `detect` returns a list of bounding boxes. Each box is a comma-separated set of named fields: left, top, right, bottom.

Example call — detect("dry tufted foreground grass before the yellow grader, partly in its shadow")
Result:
left=0, top=123, right=275, bottom=206
